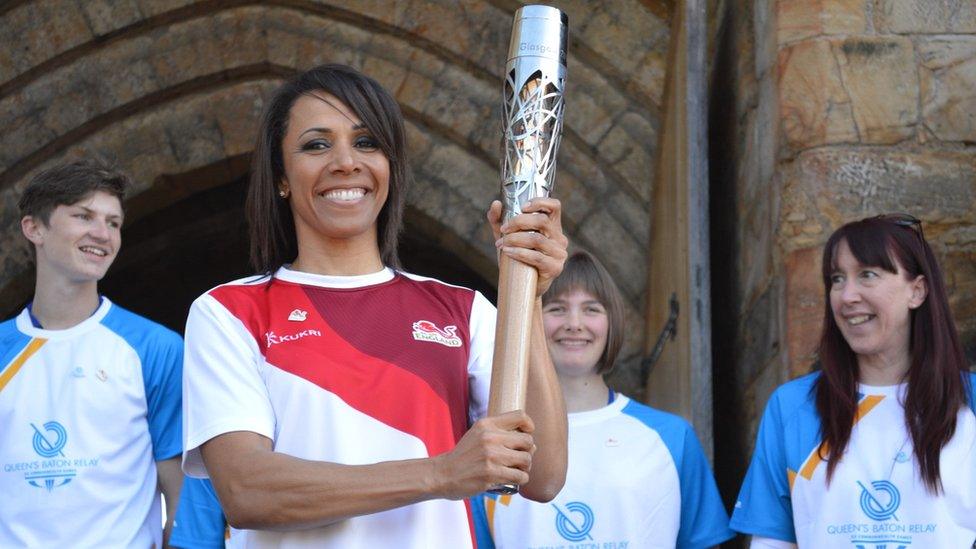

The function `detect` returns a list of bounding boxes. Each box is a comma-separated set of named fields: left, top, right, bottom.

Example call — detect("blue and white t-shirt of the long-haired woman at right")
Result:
left=731, top=374, right=976, bottom=549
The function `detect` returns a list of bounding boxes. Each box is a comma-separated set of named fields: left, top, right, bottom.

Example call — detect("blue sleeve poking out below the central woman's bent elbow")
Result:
left=169, top=477, right=227, bottom=549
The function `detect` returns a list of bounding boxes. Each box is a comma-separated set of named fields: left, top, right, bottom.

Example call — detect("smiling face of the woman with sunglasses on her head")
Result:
left=830, top=240, right=926, bottom=370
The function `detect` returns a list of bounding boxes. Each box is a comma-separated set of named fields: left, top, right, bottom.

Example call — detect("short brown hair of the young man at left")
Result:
left=17, top=159, right=132, bottom=225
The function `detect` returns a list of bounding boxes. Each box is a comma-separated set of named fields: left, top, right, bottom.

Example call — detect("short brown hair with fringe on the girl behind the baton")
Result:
left=542, top=250, right=624, bottom=374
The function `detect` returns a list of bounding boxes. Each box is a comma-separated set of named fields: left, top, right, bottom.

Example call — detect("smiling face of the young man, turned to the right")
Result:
left=22, top=191, right=122, bottom=284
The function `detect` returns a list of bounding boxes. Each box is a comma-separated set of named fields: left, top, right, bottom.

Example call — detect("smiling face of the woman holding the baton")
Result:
left=280, top=91, right=390, bottom=256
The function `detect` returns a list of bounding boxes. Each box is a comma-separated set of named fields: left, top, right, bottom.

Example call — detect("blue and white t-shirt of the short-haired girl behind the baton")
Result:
left=472, top=395, right=733, bottom=549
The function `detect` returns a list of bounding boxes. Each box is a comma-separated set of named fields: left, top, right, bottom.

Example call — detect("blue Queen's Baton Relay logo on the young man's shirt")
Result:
left=3, top=421, right=99, bottom=492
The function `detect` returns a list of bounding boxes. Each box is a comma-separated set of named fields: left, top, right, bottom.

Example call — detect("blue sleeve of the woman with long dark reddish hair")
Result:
left=729, top=392, right=796, bottom=543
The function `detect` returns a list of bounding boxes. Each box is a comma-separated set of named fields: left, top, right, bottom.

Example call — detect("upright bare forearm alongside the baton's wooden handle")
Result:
left=520, top=299, right=567, bottom=501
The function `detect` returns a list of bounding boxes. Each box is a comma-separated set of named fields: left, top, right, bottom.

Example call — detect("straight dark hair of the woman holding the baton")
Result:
left=245, top=64, right=411, bottom=273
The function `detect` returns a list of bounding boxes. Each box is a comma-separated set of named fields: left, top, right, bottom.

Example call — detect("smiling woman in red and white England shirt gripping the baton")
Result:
left=184, top=65, right=567, bottom=548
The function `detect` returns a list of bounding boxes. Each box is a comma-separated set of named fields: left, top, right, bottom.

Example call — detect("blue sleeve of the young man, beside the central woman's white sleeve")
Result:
left=142, top=330, right=183, bottom=461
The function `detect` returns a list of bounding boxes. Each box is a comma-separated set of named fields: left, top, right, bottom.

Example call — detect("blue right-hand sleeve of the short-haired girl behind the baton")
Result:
left=676, top=426, right=735, bottom=549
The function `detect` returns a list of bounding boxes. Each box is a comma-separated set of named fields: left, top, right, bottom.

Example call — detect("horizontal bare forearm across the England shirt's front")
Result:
left=204, top=435, right=437, bottom=530
